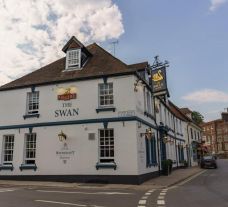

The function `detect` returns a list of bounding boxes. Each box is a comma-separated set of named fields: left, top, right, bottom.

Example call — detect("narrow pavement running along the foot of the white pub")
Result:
left=0, top=166, right=203, bottom=190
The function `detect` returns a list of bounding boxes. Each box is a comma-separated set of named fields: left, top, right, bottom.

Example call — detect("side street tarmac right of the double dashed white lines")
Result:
left=166, top=159, right=228, bottom=207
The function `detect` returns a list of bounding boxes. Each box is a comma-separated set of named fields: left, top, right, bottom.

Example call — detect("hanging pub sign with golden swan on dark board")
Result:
left=151, top=67, right=167, bottom=93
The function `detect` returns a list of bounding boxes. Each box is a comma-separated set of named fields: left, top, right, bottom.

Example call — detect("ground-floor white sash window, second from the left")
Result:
left=24, top=133, right=36, bottom=164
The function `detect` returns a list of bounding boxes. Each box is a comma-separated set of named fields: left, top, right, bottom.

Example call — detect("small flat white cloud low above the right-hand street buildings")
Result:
left=182, top=89, right=228, bottom=103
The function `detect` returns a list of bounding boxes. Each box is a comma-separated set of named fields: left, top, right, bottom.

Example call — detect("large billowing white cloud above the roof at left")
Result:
left=0, top=0, right=124, bottom=84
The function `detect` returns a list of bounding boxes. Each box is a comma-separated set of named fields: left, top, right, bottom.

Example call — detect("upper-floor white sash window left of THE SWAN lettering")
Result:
left=27, top=91, right=39, bottom=115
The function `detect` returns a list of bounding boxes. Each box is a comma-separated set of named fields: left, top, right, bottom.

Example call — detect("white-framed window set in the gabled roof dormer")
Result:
left=66, top=49, right=81, bottom=70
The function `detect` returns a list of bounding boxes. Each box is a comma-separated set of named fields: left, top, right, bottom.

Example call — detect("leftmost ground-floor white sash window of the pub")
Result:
left=2, top=135, right=14, bottom=165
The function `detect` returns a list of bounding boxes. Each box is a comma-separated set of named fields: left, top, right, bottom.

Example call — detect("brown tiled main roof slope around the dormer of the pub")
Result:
left=0, top=43, right=146, bottom=90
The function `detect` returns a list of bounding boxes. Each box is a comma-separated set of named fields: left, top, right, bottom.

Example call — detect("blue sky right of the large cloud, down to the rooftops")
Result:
left=104, top=0, right=228, bottom=120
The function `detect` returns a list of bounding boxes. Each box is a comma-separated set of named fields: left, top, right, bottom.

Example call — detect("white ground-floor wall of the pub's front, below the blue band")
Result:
left=0, top=121, right=138, bottom=175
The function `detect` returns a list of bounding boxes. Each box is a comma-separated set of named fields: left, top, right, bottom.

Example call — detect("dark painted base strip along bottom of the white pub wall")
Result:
left=0, top=172, right=159, bottom=185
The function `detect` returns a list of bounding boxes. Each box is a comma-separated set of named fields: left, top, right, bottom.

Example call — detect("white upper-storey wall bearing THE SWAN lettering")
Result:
left=0, top=75, right=136, bottom=126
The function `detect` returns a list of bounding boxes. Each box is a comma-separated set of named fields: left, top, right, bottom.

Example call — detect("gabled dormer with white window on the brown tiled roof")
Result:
left=62, top=36, right=91, bottom=71
